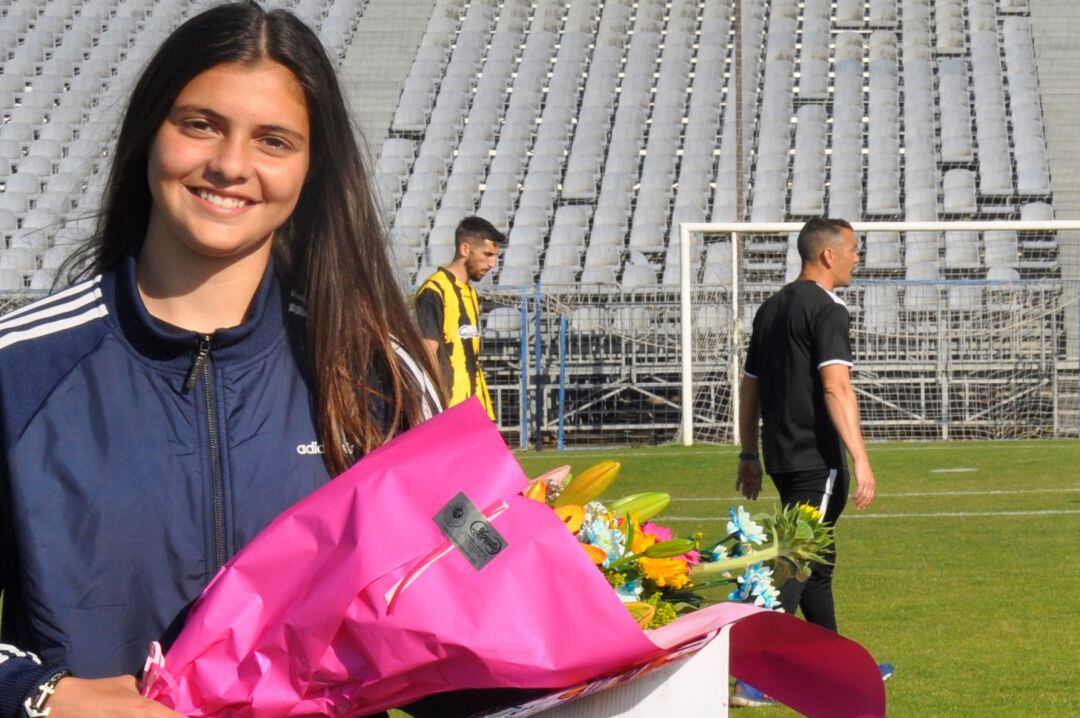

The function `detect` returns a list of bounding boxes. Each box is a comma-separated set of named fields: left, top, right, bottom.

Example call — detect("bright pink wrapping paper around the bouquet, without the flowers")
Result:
left=144, top=402, right=883, bottom=718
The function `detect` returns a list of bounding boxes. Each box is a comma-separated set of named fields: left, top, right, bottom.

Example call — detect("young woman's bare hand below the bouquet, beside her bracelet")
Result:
left=49, top=676, right=183, bottom=718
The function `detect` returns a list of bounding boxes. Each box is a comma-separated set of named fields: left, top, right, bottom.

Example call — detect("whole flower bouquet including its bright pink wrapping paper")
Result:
left=141, top=402, right=885, bottom=718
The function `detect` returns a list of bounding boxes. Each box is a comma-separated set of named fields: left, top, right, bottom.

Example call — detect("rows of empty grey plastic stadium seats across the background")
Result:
left=0, top=0, right=1058, bottom=288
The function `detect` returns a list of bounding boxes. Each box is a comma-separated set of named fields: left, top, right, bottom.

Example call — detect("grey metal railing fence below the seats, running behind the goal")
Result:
left=484, top=280, right=1080, bottom=447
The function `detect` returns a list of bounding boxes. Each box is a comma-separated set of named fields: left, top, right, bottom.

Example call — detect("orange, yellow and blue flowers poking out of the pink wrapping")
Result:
left=525, top=461, right=833, bottom=628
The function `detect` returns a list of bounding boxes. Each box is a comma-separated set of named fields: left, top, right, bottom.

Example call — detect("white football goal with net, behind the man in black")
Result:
left=678, top=220, right=1080, bottom=446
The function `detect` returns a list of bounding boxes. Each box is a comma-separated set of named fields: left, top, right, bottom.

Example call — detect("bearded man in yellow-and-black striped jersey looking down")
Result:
left=416, top=217, right=507, bottom=421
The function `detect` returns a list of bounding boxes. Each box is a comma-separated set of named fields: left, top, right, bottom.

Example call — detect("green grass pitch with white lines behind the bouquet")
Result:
left=498, top=441, right=1080, bottom=718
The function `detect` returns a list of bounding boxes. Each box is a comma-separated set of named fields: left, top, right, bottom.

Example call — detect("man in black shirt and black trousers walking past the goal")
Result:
left=735, top=219, right=875, bottom=631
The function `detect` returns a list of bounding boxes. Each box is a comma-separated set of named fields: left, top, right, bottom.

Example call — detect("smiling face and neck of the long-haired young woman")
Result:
left=137, top=59, right=311, bottom=331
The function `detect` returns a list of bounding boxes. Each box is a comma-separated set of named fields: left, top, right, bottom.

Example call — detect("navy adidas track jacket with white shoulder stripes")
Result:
left=0, top=258, right=436, bottom=718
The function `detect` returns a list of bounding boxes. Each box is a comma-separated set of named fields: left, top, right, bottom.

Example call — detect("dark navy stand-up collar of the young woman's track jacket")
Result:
left=102, top=253, right=288, bottom=368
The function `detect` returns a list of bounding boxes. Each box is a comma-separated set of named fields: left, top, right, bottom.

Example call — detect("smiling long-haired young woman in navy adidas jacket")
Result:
left=0, top=3, right=437, bottom=718
